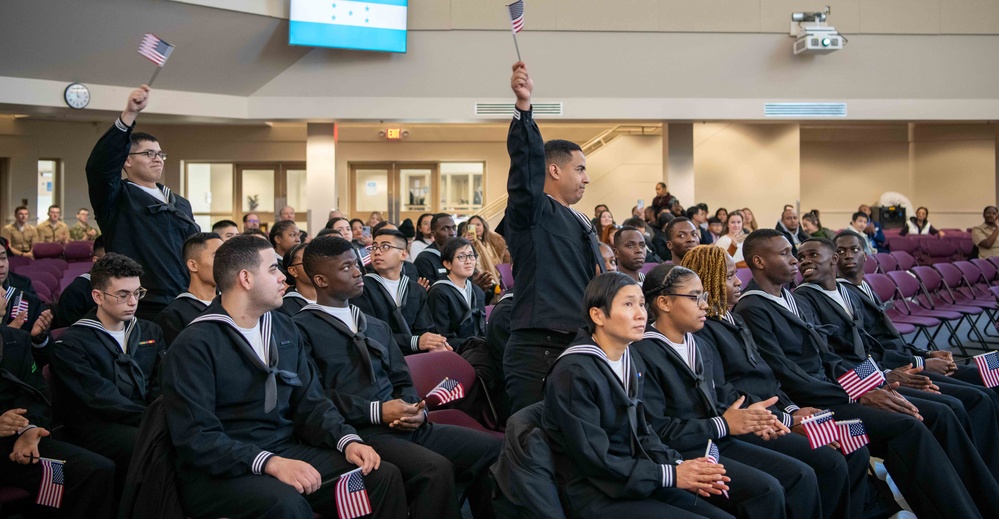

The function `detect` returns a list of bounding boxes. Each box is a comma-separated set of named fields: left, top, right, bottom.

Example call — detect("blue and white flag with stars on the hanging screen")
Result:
left=288, top=0, right=409, bottom=52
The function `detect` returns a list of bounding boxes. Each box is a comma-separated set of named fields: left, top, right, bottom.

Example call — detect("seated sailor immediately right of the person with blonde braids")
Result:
left=734, top=229, right=999, bottom=519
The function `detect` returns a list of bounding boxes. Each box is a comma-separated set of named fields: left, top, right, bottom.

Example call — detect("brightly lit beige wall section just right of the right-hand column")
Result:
left=696, top=123, right=800, bottom=227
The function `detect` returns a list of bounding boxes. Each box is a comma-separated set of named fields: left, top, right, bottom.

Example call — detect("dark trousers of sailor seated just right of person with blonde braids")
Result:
left=829, top=404, right=999, bottom=519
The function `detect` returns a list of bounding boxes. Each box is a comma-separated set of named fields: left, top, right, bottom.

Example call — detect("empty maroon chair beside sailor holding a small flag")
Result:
left=406, top=351, right=503, bottom=438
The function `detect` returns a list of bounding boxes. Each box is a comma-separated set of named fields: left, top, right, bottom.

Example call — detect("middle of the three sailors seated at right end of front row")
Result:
left=794, top=238, right=999, bottom=471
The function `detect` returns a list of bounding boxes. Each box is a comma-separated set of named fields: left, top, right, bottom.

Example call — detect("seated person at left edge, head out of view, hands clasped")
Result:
left=0, top=326, right=115, bottom=518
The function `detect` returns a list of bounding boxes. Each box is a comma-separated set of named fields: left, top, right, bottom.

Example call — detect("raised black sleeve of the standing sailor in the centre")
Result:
left=504, top=109, right=546, bottom=231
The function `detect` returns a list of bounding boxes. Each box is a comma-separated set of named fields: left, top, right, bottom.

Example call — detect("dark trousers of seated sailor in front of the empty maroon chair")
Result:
left=364, top=423, right=503, bottom=519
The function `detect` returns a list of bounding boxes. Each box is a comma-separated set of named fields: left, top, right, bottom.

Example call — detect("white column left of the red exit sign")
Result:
left=305, top=123, right=337, bottom=236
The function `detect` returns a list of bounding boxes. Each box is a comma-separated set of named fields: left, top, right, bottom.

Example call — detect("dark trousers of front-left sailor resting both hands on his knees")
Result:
left=178, top=444, right=407, bottom=519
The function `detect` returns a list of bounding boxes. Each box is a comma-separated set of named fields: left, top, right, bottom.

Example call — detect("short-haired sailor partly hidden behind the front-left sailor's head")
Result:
left=156, top=232, right=225, bottom=346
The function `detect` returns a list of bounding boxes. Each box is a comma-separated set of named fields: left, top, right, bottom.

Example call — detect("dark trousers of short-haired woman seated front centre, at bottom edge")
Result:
left=574, top=488, right=735, bottom=519
